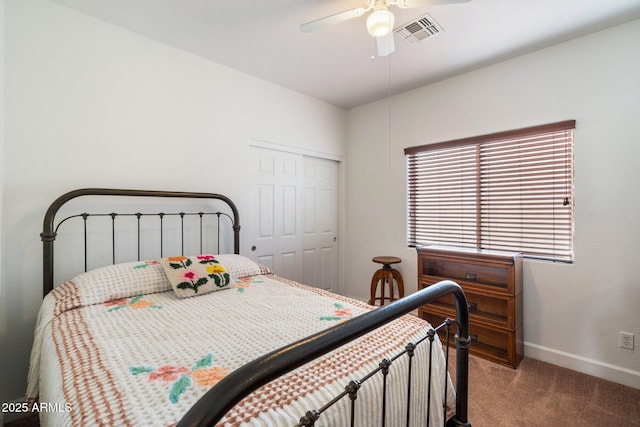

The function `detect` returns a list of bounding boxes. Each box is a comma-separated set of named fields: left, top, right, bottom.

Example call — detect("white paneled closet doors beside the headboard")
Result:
left=250, top=147, right=338, bottom=291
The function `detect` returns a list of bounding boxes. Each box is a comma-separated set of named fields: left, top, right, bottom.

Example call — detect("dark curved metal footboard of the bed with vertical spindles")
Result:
left=178, top=281, right=471, bottom=427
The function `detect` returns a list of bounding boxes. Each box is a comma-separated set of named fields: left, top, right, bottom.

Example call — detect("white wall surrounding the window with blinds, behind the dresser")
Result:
left=346, top=20, right=640, bottom=388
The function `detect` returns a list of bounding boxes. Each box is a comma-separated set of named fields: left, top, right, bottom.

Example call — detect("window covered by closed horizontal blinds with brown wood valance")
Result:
left=405, top=120, right=575, bottom=262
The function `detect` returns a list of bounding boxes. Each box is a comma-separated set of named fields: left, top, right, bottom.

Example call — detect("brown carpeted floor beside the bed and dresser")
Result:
left=6, top=356, right=640, bottom=427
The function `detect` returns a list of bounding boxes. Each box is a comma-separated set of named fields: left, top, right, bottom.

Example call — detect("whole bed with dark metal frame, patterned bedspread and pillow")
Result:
left=27, top=189, right=470, bottom=426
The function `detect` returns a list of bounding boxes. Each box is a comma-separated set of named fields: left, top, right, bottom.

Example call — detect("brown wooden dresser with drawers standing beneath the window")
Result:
left=418, top=246, right=524, bottom=368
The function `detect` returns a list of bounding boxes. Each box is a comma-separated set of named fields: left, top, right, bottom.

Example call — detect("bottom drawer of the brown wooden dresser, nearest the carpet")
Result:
left=420, top=308, right=522, bottom=368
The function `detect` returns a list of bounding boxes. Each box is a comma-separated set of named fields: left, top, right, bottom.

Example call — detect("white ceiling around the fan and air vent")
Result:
left=53, top=0, right=640, bottom=108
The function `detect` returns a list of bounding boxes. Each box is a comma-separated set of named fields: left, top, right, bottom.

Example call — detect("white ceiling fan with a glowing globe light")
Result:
left=300, top=0, right=470, bottom=56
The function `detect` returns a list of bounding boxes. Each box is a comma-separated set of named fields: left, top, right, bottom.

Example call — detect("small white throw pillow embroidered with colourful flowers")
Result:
left=160, top=254, right=231, bottom=298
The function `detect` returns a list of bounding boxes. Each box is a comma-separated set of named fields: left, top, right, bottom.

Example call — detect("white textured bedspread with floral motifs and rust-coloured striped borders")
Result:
left=27, top=262, right=455, bottom=426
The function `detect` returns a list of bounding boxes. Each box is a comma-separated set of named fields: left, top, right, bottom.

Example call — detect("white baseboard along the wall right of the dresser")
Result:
left=524, top=342, right=640, bottom=389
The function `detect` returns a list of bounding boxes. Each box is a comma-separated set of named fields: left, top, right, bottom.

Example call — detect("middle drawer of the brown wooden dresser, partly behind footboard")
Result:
left=420, top=280, right=516, bottom=329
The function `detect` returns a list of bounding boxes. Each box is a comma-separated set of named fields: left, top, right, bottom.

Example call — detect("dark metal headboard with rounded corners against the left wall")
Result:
left=40, top=188, right=240, bottom=295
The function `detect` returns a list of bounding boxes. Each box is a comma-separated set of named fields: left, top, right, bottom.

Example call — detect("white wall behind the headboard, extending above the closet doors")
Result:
left=0, top=0, right=346, bottom=401
